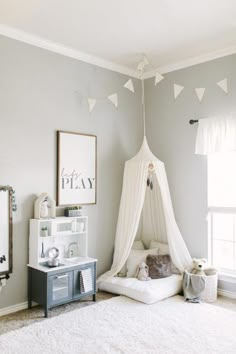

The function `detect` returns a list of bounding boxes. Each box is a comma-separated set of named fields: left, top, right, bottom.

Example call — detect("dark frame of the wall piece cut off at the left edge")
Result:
left=0, top=186, right=13, bottom=276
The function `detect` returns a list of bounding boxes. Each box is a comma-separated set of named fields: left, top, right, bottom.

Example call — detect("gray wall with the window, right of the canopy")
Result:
left=145, top=55, right=236, bottom=291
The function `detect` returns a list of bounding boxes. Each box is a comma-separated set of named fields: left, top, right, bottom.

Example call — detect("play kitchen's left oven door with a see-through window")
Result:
left=48, top=272, right=73, bottom=306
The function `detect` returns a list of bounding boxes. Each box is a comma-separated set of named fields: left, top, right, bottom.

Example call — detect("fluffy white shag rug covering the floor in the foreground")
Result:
left=0, top=296, right=236, bottom=354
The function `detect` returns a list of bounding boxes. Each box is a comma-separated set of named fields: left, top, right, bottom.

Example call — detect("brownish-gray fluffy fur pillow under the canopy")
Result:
left=146, top=254, right=172, bottom=279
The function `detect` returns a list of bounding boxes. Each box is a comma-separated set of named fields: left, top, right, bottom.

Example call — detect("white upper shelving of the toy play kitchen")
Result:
left=29, top=216, right=88, bottom=266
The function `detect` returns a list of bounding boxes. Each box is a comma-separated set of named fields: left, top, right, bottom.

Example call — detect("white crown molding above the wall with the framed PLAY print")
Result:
left=0, top=24, right=138, bottom=78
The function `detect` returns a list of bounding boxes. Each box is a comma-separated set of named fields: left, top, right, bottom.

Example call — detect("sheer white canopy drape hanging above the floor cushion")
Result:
left=98, top=137, right=192, bottom=284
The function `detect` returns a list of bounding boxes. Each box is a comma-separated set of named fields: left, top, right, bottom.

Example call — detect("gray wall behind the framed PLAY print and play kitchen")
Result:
left=0, top=36, right=143, bottom=308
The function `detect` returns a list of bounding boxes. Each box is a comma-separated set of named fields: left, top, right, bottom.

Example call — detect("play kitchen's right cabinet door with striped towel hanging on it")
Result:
left=74, top=263, right=95, bottom=298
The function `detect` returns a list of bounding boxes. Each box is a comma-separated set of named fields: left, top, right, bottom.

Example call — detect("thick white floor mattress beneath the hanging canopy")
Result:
left=99, top=274, right=182, bottom=304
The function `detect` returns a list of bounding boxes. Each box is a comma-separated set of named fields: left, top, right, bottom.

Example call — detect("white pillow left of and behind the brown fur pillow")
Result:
left=126, top=248, right=159, bottom=278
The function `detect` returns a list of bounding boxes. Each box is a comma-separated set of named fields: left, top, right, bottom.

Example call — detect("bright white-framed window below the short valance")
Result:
left=208, top=152, right=236, bottom=274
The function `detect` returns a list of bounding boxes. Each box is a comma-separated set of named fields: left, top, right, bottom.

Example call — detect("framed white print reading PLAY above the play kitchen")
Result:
left=57, top=131, right=97, bottom=206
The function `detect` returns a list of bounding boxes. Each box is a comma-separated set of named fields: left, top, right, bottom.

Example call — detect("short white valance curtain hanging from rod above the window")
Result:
left=195, top=115, right=236, bottom=155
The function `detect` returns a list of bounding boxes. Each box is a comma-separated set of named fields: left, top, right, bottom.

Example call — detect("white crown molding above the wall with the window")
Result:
left=143, top=45, right=236, bottom=79
